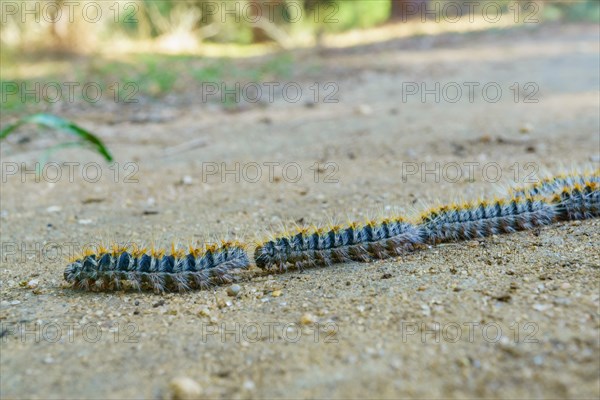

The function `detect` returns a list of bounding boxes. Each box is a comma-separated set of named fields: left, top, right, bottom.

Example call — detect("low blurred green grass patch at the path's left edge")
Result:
left=0, top=52, right=300, bottom=113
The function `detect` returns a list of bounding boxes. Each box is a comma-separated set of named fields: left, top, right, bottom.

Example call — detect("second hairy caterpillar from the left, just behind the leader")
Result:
left=254, top=218, right=423, bottom=270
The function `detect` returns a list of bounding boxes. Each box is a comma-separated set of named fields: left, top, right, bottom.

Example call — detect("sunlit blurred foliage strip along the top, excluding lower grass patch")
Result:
left=0, top=0, right=600, bottom=53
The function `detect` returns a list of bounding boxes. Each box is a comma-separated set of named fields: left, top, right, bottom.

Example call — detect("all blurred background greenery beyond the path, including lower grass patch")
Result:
left=0, top=0, right=600, bottom=112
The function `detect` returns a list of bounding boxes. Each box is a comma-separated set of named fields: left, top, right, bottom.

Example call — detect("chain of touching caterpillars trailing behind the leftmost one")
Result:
left=254, top=170, right=600, bottom=270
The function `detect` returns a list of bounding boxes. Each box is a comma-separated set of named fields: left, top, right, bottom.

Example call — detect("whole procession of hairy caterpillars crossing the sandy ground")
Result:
left=64, top=170, right=600, bottom=292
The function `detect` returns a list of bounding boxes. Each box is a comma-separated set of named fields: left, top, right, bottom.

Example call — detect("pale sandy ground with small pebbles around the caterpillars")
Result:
left=0, top=26, right=600, bottom=399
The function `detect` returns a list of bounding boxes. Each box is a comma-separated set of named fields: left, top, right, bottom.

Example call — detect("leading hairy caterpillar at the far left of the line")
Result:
left=64, top=242, right=250, bottom=292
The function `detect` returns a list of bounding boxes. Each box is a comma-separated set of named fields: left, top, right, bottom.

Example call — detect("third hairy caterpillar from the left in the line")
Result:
left=420, top=197, right=557, bottom=244
